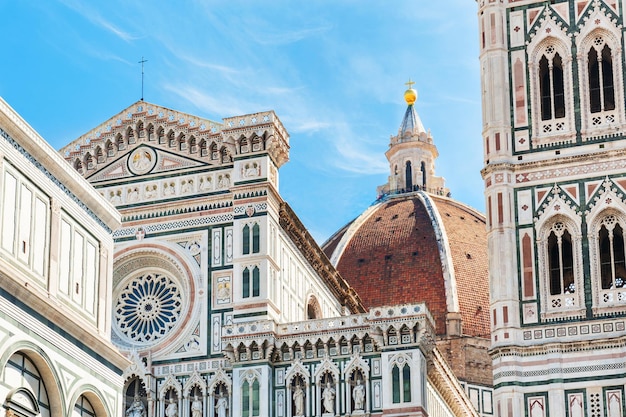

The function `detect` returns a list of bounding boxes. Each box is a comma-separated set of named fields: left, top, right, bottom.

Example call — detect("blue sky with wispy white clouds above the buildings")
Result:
left=0, top=0, right=484, bottom=243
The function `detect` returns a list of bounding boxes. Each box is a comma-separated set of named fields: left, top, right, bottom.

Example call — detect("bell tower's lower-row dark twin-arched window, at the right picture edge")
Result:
left=598, top=215, right=626, bottom=290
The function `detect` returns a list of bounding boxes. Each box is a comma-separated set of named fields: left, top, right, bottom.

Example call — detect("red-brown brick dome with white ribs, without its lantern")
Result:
left=323, top=191, right=490, bottom=338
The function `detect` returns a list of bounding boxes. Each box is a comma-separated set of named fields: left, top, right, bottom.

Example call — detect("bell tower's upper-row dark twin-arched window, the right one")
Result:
left=587, top=36, right=615, bottom=113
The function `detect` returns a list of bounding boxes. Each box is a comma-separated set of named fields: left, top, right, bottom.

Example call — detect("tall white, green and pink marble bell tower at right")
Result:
left=478, top=0, right=626, bottom=417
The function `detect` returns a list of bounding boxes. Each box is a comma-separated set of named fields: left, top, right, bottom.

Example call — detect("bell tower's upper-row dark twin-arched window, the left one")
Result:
left=539, top=45, right=565, bottom=120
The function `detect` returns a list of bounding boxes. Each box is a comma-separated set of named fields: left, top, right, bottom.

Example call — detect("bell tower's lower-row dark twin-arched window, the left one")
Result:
left=548, top=222, right=576, bottom=295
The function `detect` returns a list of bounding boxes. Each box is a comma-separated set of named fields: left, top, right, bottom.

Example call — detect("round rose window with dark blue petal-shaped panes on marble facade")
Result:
left=115, top=274, right=182, bottom=343
